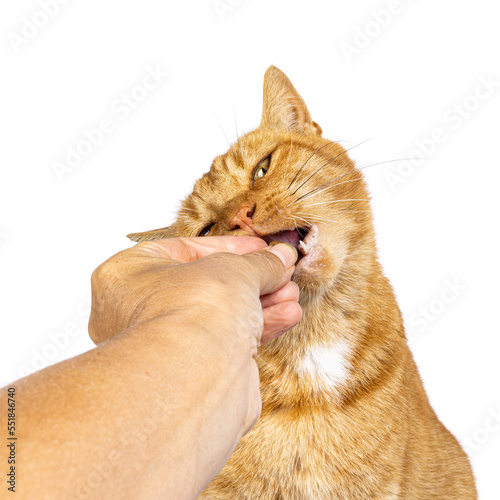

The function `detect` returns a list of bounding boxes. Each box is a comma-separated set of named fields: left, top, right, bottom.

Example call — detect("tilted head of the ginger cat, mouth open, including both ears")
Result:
left=129, top=66, right=373, bottom=292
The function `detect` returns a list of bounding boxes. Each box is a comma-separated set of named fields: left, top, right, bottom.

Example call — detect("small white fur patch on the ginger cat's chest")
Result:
left=297, top=341, right=351, bottom=390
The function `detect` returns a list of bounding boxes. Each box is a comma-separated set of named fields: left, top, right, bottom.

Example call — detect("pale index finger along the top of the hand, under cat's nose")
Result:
left=134, top=236, right=267, bottom=262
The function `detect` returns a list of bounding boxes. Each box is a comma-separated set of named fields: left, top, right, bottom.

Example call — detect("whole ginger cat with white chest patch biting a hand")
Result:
left=129, top=66, right=477, bottom=500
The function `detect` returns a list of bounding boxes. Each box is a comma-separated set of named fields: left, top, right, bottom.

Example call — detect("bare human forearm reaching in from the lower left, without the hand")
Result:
left=10, top=315, right=257, bottom=499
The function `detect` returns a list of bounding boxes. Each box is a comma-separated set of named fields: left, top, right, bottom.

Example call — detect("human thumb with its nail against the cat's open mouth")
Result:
left=241, top=243, right=298, bottom=295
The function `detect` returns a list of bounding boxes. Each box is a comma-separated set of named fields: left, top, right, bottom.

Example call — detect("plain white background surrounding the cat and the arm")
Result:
left=0, top=0, right=500, bottom=500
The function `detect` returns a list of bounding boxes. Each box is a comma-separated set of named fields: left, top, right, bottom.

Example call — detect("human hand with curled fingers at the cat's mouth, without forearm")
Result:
left=89, top=236, right=302, bottom=345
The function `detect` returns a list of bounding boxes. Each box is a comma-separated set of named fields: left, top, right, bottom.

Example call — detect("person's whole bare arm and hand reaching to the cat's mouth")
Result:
left=0, top=237, right=301, bottom=499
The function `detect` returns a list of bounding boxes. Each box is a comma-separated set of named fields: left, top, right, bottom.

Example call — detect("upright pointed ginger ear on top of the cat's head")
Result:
left=260, top=66, right=322, bottom=135
